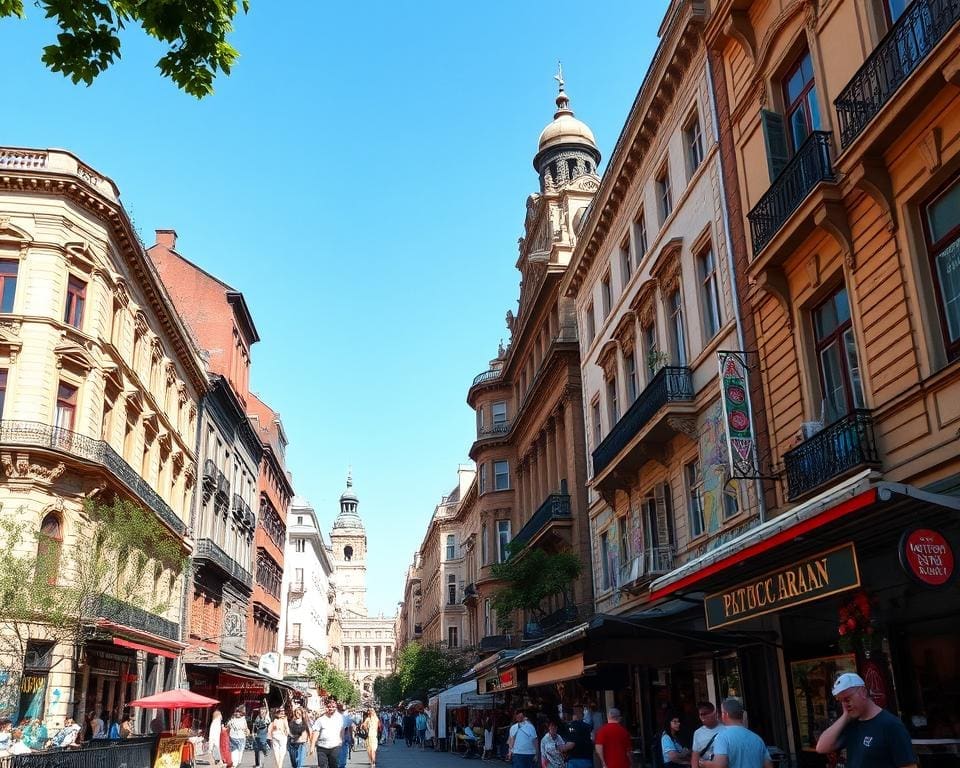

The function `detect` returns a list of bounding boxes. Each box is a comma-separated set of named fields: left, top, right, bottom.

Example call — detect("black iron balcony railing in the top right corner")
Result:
left=833, top=0, right=960, bottom=149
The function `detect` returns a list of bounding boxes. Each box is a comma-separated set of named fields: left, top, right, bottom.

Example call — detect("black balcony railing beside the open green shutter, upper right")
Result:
left=747, top=131, right=835, bottom=258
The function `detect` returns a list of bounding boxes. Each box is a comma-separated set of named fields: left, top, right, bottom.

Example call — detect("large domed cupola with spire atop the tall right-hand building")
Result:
left=533, top=69, right=600, bottom=192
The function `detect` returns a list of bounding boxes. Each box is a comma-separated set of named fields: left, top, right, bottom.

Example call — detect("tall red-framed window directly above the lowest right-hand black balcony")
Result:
left=813, top=288, right=864, bottom=424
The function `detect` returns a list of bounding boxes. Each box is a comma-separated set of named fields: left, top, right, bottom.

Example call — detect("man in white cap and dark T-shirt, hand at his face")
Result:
left=817, top=672, right=917, bottom=768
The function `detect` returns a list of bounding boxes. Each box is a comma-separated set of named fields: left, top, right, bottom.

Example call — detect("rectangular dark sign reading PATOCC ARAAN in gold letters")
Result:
left=703, top=542, right=860, bottom=629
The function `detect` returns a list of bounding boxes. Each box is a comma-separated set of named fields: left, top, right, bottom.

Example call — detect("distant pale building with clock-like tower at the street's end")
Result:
left=330, top=476, right=396, bottom=703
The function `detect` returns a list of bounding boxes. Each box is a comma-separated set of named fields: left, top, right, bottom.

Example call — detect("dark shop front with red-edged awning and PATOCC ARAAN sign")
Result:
left=652, top=478, right=960, bottom=768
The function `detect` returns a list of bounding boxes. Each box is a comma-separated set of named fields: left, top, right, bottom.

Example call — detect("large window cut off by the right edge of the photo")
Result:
left=923, top=177, right=960, bottom=360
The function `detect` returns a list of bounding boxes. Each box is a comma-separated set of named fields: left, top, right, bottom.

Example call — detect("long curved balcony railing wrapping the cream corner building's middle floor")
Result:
left=0, top=421, right=187, bottom=536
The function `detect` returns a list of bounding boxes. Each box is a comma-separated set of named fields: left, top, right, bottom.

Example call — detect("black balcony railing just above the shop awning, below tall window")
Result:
left=783, top=410, right=880, bottom=501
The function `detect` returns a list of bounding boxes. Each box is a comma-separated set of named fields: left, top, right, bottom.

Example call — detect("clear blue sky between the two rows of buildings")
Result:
left=0, top=0, right=667, bottom=614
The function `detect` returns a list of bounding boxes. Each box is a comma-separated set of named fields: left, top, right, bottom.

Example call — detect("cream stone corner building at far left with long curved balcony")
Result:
left=0, top=148, right=207, bottom=725
